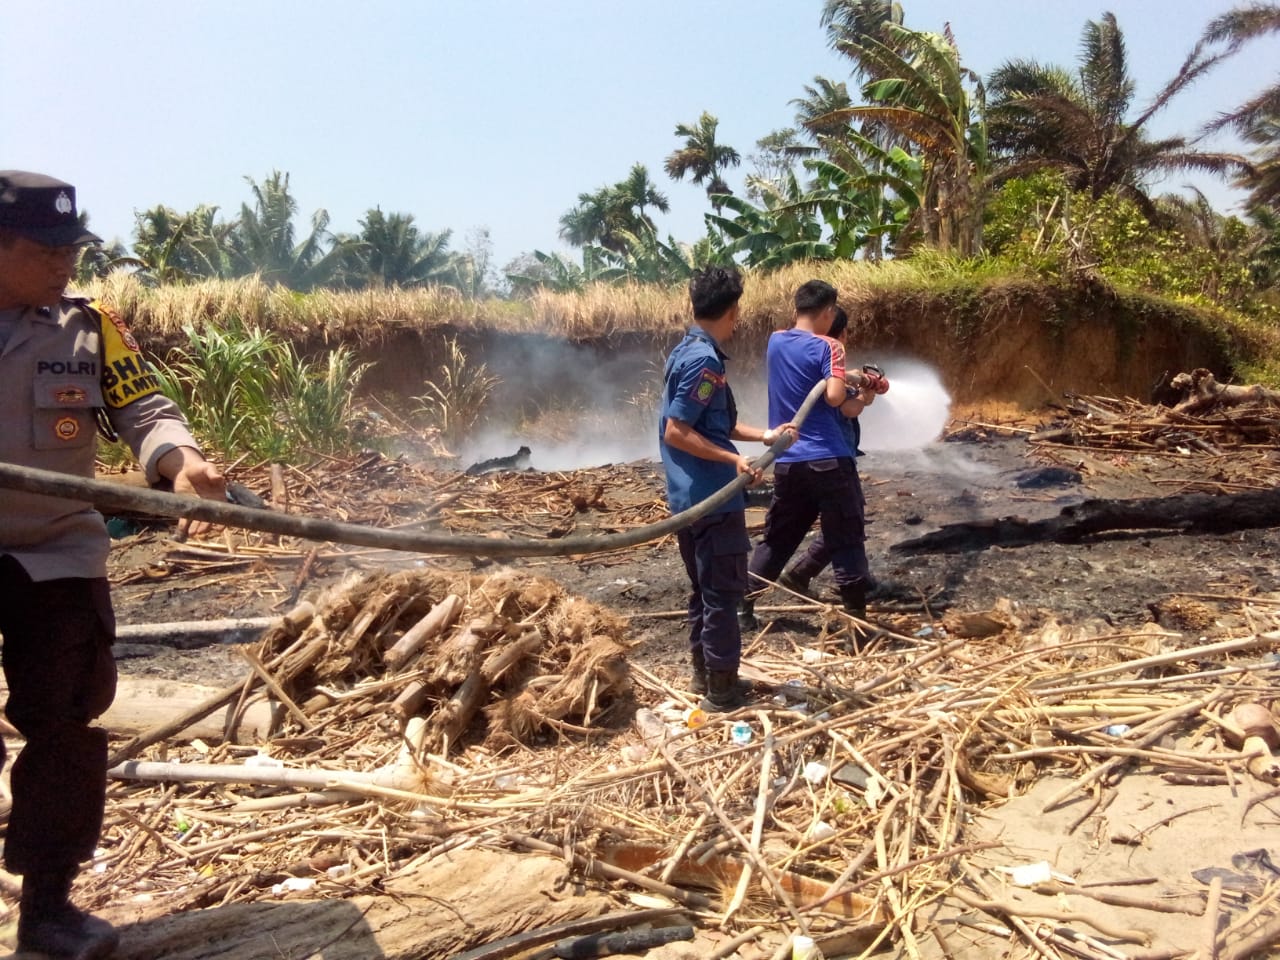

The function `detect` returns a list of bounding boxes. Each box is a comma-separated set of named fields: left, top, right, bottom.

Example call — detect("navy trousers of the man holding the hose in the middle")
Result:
left=676, top=511, right=751, bottom=671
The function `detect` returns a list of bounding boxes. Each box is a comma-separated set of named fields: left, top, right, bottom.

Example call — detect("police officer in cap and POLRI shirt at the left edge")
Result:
left=0, top=170, right=225, bottom=960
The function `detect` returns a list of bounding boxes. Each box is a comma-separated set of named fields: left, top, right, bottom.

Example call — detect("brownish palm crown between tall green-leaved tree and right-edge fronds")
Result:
left=987, top=13, right=1247, bottom=218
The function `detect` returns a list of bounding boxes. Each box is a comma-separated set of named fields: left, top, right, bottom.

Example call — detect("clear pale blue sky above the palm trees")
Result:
left=0, top=0, right=1280, bottom=271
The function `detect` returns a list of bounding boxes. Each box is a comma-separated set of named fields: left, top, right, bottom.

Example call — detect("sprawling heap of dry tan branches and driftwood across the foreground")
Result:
left=60, top=571, right=1280, bottom=957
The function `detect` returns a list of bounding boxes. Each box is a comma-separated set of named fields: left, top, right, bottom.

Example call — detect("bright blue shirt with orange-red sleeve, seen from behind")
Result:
left=767, top=328, right=854, bottom=463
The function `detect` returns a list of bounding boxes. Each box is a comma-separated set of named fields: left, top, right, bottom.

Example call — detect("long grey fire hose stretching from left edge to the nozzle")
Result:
left=0, top=380, right=826, bottom=559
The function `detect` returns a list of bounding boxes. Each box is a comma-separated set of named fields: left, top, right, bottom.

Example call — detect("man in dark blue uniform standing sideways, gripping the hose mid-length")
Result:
left=658, top=266, right=795, bottom=712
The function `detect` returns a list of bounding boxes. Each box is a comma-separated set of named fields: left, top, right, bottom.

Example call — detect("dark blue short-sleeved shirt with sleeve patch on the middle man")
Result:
left=658, top=326, right=746, bottom=513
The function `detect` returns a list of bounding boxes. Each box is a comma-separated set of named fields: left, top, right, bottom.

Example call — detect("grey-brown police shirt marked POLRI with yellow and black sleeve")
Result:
left=0, top=297, right=197, bottom=581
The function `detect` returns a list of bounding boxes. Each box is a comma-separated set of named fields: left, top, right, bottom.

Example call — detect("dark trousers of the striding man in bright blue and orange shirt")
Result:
left=751, top=457, right=870, bottom=586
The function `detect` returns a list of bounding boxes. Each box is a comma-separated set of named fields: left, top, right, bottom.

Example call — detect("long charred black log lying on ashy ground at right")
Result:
left=890, top=489, right=1280, bottom=553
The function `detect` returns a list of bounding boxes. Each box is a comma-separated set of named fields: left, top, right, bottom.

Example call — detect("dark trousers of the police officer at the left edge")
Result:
left=0, top=556, right=115, bottom=873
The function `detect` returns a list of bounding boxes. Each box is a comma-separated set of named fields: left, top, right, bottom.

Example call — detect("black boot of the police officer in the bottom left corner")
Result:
left=18, top=867, right=120, bottom=960
